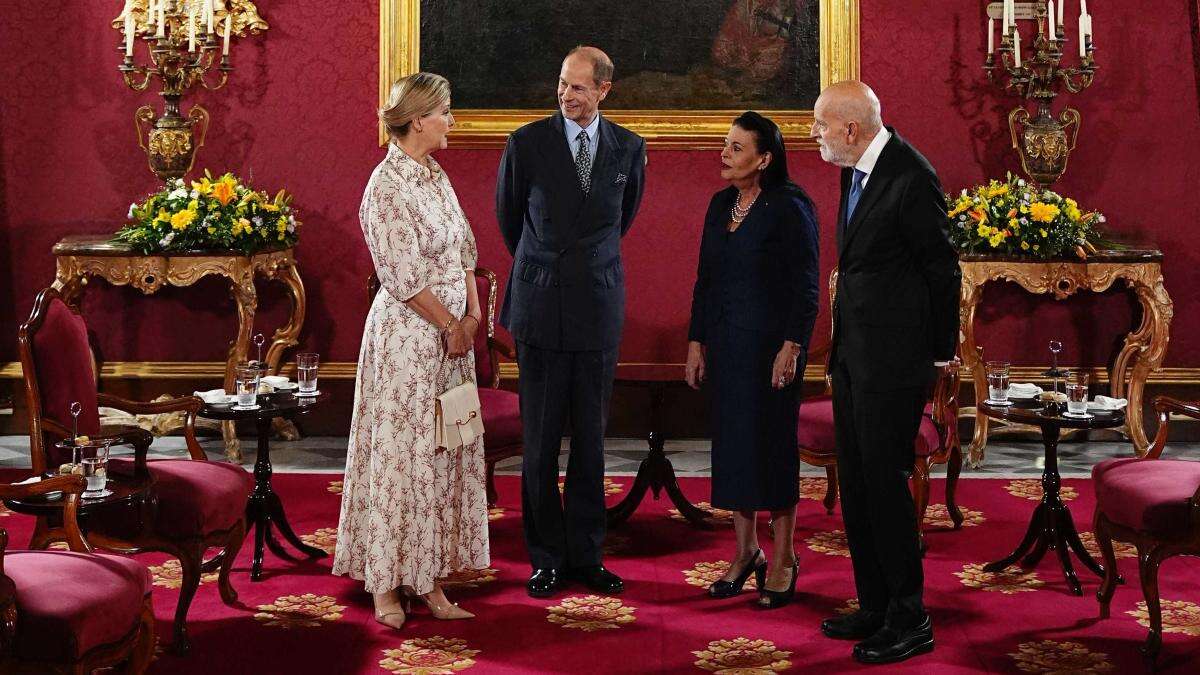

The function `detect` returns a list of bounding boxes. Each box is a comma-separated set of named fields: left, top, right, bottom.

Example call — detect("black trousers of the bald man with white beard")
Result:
left=833, top=363, right=925, bottom=628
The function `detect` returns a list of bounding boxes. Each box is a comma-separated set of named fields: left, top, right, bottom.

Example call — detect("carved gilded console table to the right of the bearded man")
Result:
left=959, top=249, right=1174, bottom=466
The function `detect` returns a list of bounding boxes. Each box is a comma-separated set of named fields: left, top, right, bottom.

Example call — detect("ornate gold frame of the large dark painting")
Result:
left=379, top=0, right=859, bottom=149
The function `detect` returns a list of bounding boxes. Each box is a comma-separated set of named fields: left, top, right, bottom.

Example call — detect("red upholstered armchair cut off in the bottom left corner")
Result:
left=0, top=476, right=155, bottom=674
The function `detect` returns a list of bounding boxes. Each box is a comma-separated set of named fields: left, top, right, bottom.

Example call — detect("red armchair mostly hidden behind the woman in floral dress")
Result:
left=367, top=267, right=524, bottom=506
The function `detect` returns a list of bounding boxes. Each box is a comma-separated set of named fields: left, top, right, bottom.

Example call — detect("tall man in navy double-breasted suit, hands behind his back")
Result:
left=496, top=47, right=646, bottom=597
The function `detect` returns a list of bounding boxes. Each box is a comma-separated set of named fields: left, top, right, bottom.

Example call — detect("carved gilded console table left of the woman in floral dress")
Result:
left=54, top=234, right=305, bottom=461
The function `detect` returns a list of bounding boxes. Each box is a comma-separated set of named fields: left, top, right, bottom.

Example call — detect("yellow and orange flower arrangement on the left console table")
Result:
left=113, top=171, right=300, bottom=253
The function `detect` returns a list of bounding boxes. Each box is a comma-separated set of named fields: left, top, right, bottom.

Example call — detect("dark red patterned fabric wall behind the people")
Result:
left=0, top=0, right=1200, bottom=366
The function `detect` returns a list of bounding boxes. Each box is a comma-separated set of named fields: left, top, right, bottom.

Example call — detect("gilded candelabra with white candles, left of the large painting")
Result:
left=113, top=0, right=268, bottom=181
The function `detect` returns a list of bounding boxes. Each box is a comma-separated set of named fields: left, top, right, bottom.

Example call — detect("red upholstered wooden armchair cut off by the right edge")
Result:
left=1092, top=396, right=1200, bottom=669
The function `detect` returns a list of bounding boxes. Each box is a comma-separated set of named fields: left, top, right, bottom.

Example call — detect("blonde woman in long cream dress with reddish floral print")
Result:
left=334, top=73, right=491, bottom=628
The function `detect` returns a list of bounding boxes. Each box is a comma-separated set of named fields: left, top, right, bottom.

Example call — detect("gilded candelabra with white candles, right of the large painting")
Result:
left=983, top=0, right=1096, bottom=187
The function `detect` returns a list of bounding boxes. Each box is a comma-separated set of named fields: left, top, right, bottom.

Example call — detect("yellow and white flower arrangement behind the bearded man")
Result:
left=946, top=174, right=1111, bottom=258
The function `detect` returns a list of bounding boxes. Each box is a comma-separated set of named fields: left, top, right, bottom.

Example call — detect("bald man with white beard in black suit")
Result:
left=812, top=82, right=961, bottom=663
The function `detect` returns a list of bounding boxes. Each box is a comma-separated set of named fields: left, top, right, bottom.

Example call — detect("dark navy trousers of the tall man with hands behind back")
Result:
left=517, top=342, right=617, bottom=569
